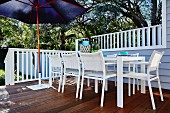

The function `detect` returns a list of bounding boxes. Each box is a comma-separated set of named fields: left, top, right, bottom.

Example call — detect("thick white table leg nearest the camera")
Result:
left=117, top=57, right=123, bottom=108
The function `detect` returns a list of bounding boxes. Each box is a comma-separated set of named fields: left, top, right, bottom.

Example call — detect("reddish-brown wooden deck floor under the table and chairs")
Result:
left=0, top=78, right=170, bottom=113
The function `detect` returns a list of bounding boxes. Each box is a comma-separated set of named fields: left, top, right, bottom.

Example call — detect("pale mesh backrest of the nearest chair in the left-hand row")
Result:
left=80, top=52, right=105, bottom=71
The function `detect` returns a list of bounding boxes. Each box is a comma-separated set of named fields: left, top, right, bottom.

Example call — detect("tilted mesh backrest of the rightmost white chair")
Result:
left=148, top=50, right=164, bottom=71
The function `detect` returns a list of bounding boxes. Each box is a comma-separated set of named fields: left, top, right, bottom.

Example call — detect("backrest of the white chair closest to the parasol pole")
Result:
left=48, top=54, right=62, bottom=67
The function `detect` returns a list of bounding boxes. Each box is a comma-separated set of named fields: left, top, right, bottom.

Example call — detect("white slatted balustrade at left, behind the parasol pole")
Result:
left=4, top=48, right=75, bottom=85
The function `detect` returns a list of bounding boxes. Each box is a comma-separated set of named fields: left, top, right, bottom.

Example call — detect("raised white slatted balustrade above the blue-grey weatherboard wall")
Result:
left=76, top=25, right=166, bottom=51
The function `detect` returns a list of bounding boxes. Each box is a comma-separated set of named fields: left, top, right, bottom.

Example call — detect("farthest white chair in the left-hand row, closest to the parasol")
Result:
left=48, top=54, right=63, bottom=92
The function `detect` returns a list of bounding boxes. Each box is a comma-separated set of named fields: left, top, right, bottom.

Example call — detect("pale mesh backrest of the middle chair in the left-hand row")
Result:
left=62, top=53, right=80, bottom=69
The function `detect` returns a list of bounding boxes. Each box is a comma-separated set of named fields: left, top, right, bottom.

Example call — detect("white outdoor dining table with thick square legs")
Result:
left=104, top=56, right=145, bottom=108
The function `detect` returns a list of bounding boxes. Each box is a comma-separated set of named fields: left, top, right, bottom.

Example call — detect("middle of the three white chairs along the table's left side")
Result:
left=62, top=53, right=81, bottom=98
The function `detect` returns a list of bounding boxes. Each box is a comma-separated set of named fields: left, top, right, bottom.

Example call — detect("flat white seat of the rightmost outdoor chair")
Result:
left=123, top=72, right=156, bottom=80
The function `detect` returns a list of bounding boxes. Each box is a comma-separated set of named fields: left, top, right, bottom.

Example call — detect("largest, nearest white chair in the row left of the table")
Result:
left=80, top=52, right=116, bottom=107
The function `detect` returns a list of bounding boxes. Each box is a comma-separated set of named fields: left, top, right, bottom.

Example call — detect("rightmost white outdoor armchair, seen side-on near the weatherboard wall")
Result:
left=124, top=51, right=164, bottom=110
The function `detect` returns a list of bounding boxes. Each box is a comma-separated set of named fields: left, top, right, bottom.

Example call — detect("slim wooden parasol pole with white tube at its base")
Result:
left=36, top=6, right=41, bottom=85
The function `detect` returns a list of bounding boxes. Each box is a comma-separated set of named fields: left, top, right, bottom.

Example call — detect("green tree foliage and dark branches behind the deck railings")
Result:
left=0, top=0, right=162, bottom=50
